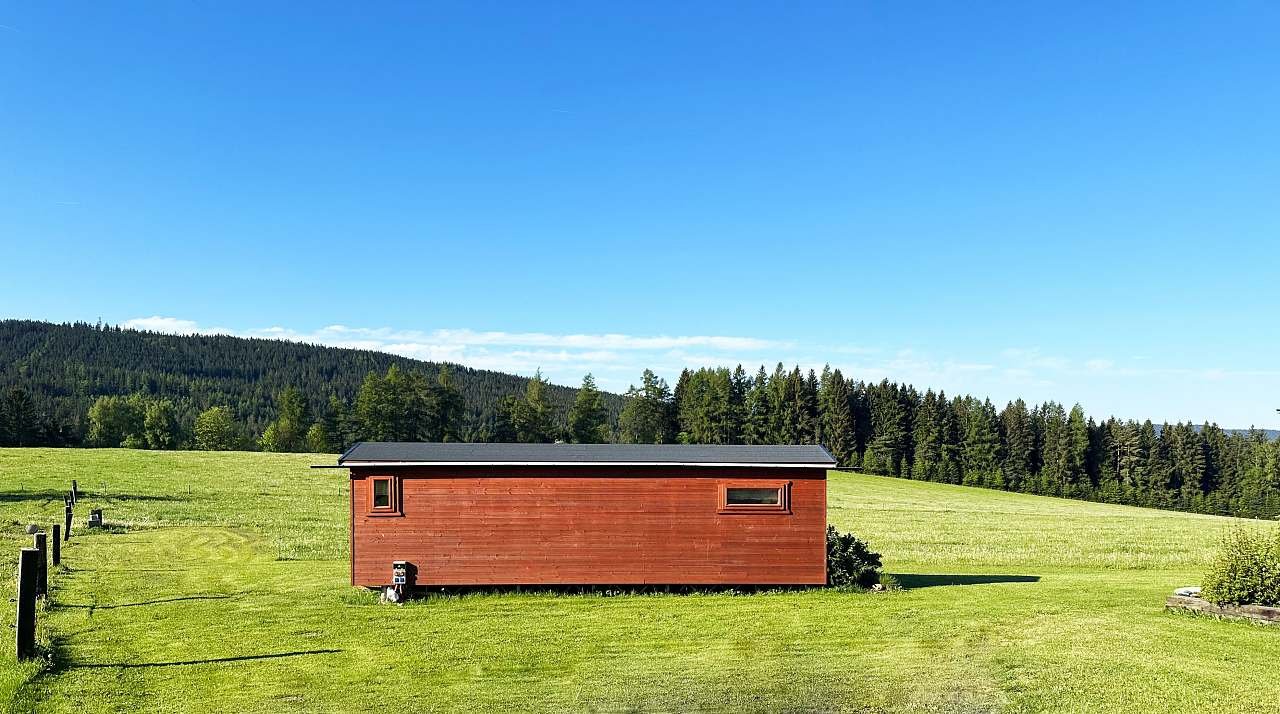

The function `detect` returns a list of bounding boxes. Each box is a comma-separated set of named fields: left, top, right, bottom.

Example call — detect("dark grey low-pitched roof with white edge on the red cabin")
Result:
left=338, top=441, right=836, bottom=468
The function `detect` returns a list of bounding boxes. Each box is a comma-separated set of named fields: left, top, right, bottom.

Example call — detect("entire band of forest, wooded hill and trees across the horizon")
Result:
left=0, top=320, right=1280, bottom=518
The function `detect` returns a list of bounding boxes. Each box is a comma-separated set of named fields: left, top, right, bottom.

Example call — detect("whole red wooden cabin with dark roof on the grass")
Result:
left=325, top=443, right=835, bottom=587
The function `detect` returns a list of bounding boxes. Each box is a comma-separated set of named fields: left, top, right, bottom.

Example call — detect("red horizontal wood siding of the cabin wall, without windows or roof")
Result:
left=352, top=467, right=827, bottom=586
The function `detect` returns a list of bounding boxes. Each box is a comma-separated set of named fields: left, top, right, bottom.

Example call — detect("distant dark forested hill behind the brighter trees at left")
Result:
left=0, top=320, right=622, bottom=445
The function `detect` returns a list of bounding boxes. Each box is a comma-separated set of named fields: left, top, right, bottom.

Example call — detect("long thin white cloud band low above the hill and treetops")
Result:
left=124, top=315, right=1280, bottom=426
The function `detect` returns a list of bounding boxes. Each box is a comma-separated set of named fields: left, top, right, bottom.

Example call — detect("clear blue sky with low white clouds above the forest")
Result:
left=0, top=3, right=1280, bottom=426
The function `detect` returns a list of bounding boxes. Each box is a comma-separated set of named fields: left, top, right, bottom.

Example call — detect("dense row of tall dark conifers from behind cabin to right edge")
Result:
left=660, top=365, right=1280, bottom=518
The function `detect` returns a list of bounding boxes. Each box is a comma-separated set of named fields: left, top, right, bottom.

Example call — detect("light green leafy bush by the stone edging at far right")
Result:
left=1201, top=530, right=1280, bottom=607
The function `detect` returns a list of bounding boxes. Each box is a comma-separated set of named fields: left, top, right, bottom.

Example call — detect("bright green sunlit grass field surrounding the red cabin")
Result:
left=0, top=449, right=1280, bottom=711
